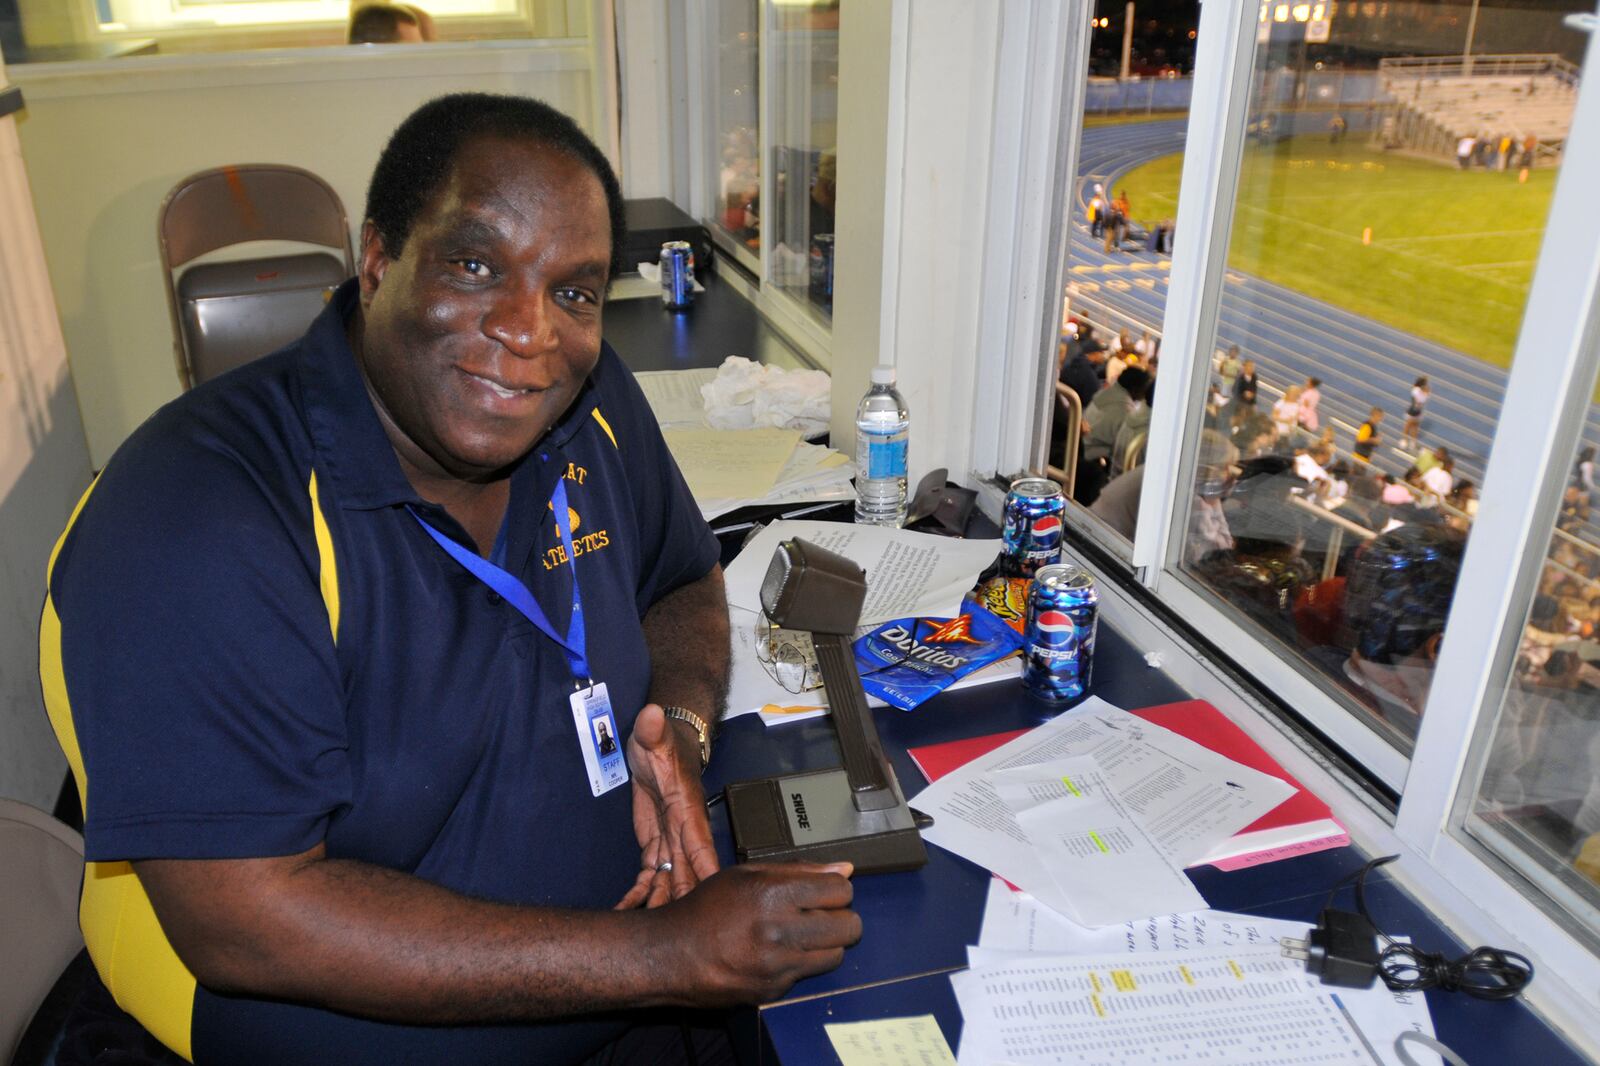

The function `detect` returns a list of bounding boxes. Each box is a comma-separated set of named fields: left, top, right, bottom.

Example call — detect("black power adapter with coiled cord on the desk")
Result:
left=1280, top=855, right=1533, bottom=1000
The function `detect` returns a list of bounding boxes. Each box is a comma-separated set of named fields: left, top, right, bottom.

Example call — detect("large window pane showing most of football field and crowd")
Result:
left=1176, top=3, right=1595, bottom=752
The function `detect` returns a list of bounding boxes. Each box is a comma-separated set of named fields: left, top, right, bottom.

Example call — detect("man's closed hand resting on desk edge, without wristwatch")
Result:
left=653, top=863, right=861, bottom=1007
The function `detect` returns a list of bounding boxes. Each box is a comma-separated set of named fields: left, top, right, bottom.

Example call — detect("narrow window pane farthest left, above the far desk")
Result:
left=706, top=0, right=762, bottom=269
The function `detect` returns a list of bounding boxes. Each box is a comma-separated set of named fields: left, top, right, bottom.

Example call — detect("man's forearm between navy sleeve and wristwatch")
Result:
left=645, top=567, right=730, bottom=722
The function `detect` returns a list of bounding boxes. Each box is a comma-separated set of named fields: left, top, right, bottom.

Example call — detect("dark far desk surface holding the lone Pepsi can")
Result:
left=603, top=267, right=808, bottom=373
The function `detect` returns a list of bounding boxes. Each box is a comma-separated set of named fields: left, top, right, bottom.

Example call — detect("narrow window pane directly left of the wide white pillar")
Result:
left=762, top=0, right=838, bottom=322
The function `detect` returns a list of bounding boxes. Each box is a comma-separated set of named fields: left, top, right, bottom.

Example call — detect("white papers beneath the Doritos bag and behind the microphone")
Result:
left=725, top=520, right=1021, bottom=725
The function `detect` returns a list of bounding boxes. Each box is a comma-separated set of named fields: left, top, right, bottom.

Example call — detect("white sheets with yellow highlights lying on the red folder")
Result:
left=910, top=698, right=1294, bottom=927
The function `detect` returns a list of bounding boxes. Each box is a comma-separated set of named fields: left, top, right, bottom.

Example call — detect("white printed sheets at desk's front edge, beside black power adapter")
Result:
left=952, top=879, right=1438, bottom=1066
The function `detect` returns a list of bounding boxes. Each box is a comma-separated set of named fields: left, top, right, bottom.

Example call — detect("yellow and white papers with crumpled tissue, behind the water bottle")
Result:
left=635, top=355, right=854, bottom=520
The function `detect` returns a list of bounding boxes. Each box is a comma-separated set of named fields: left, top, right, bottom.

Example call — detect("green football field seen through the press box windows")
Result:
left=1117, top=134, right=1555, bottom=367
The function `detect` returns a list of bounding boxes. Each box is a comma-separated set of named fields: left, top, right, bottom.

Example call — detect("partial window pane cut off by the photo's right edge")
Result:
left=1466, top=427, right=1600, bottom=930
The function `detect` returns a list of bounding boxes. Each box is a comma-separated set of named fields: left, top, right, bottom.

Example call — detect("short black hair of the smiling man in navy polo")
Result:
left=366, top=93, right=624, bottom=277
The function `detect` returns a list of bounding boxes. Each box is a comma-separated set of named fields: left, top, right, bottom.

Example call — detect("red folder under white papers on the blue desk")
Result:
left=906, top=699, right=1350, bottom=869
